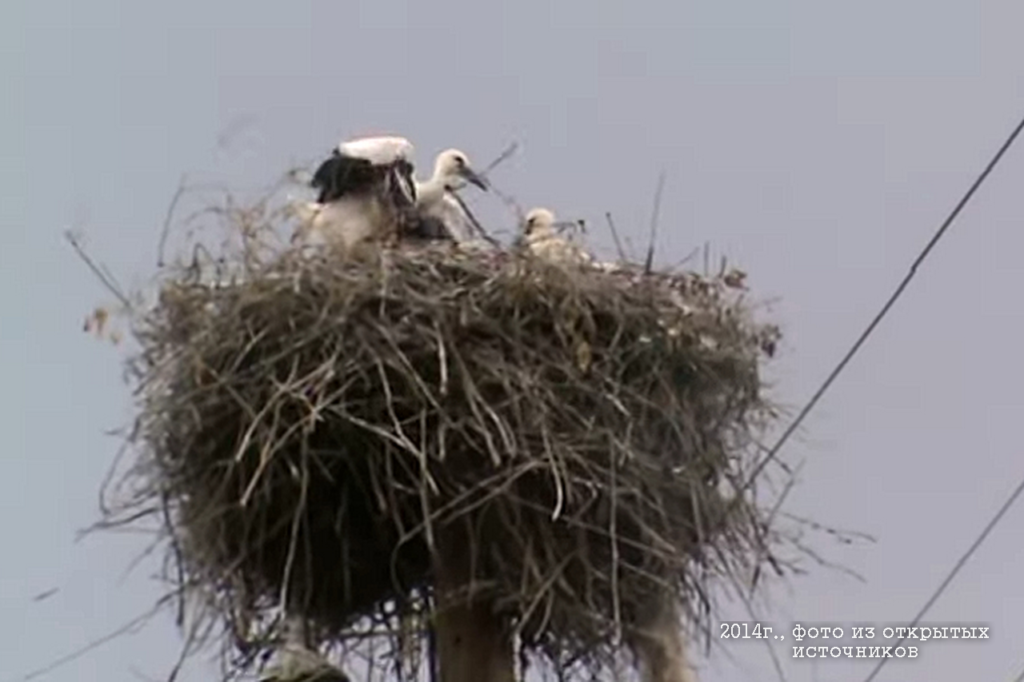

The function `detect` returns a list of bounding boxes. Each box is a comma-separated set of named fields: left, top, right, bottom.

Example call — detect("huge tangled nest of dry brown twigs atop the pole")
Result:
left=103, top=193, right=778, bottom=671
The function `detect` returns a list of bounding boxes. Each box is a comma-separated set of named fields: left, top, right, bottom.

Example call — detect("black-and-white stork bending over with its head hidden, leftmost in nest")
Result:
left=294, top=137, right=416, bottom=252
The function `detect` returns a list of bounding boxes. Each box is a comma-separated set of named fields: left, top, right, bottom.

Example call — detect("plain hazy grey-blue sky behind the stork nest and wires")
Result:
left=0, top=0, right=1024, bottom=682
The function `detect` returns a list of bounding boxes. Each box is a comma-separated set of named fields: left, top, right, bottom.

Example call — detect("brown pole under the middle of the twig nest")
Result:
left=433, top=531, right=515, bottom=682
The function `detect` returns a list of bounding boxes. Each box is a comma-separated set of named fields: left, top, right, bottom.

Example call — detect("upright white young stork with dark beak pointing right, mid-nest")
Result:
left=407, top=150, right=487, bottom=243
